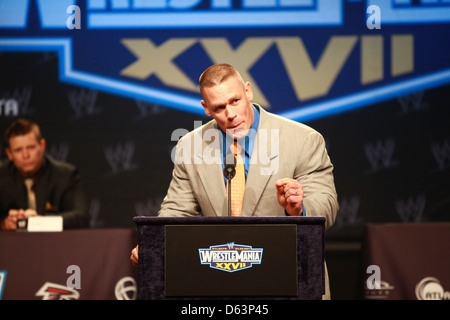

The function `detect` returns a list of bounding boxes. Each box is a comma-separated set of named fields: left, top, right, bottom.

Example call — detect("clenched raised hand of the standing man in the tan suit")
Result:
left=275, top=178, right=303, bottom=216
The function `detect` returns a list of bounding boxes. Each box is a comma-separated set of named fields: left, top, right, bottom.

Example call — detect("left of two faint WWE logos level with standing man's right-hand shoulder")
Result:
left=364, top=139, right=397, bottom=172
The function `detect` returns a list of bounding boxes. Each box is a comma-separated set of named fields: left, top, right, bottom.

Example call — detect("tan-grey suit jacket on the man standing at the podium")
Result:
left=159, top=106, right=338, bottom=228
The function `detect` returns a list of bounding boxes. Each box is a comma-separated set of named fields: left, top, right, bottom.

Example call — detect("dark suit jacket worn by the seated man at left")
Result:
left=0, top=155, right=89, bottom=229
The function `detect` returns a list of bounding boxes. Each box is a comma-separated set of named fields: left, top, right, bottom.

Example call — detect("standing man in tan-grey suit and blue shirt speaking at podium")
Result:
left=131, top=64, right=338, bottom=299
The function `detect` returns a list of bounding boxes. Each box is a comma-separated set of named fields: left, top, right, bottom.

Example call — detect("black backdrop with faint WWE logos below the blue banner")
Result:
left=0, top=52, right=450, bottom=236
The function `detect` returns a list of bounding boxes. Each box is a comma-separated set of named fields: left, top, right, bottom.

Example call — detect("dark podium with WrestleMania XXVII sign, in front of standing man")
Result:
left=133, top=216, right=325, bottom=300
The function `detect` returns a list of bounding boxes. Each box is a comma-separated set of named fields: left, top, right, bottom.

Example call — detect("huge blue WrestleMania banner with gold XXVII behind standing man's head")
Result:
left=0, top=0, right=450, bottom=121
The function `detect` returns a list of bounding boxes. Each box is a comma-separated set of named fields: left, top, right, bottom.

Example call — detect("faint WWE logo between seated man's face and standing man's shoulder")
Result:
left=104, top=142, right=137, bottom=173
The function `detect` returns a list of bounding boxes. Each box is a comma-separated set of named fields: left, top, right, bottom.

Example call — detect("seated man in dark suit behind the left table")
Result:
left=0, top=119, right=89, bottom=230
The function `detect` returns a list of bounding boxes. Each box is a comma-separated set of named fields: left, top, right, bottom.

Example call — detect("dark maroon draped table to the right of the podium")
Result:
left=362, top=222, right=450, bottom=300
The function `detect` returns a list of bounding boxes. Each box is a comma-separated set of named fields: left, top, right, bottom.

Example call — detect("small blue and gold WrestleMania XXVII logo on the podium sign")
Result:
left=198, top=242, right=263, bottom=272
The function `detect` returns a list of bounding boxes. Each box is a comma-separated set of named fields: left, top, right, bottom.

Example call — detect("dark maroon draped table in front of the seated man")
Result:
left=0, top=229, right=138, bottom=300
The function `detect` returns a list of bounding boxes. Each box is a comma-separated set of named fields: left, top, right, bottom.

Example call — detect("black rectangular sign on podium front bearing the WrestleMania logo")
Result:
left=165, top=225, right=297, bottom=297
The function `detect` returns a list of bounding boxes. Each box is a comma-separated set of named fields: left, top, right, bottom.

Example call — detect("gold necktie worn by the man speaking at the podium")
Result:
left=227, top=141, right=245, bottom=216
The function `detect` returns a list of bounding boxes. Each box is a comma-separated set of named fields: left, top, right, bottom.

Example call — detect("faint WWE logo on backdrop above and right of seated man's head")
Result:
left=67, top=89, right=101, bottom=119
